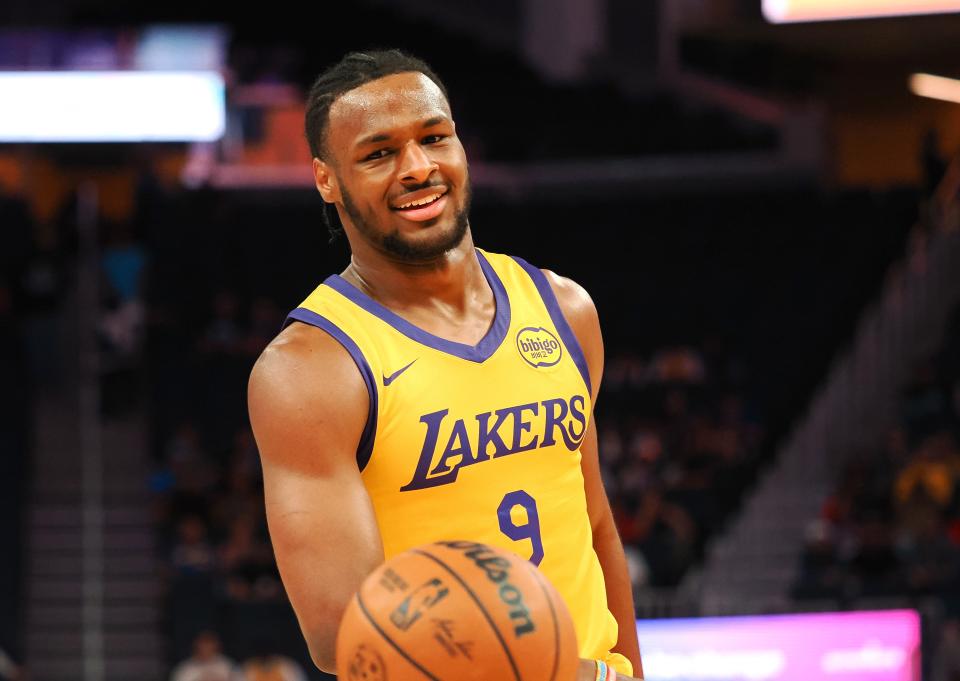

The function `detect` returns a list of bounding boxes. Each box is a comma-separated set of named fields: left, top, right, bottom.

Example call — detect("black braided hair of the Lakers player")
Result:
left=304, top=48, right=450, bottom=241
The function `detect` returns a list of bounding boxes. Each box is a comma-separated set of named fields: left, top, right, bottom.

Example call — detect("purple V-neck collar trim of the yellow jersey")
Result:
left=323, top=250, right=510, bottom=364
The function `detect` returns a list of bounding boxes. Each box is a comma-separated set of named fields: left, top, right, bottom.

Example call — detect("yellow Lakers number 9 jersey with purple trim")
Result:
left=286, top=249, right=632, bottom=675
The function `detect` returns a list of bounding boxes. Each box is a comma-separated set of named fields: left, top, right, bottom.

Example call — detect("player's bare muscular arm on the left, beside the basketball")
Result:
left=248, top=324, right=383, bottom=673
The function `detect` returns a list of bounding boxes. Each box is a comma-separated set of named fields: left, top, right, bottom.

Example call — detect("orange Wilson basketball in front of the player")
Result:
left=337, top=541, right=579, bottom=681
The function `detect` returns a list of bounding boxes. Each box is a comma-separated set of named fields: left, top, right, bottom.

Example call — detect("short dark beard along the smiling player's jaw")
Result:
left=340, top=179, right=473, bottom=263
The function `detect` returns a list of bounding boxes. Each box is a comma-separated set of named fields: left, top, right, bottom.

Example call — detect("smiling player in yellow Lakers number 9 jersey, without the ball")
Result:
left=249, top=50, right=643, bottom=681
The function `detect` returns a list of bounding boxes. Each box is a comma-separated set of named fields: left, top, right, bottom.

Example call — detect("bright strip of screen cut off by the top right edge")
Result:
left=763, top=0, right=960, bottom=24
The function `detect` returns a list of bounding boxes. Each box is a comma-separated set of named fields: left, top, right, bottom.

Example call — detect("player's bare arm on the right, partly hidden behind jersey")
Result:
left=544, top=270, right=643, bottom=679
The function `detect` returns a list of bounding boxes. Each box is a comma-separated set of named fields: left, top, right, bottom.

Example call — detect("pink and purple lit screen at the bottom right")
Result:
left=637, top=610, right=920, bottom=681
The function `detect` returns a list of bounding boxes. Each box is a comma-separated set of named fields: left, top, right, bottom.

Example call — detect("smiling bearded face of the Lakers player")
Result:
left=313, top=72, right=470, bottom=263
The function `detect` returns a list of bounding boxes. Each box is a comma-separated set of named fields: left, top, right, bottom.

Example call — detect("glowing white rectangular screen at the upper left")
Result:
left=0, top=71, right=226, bottom=142
